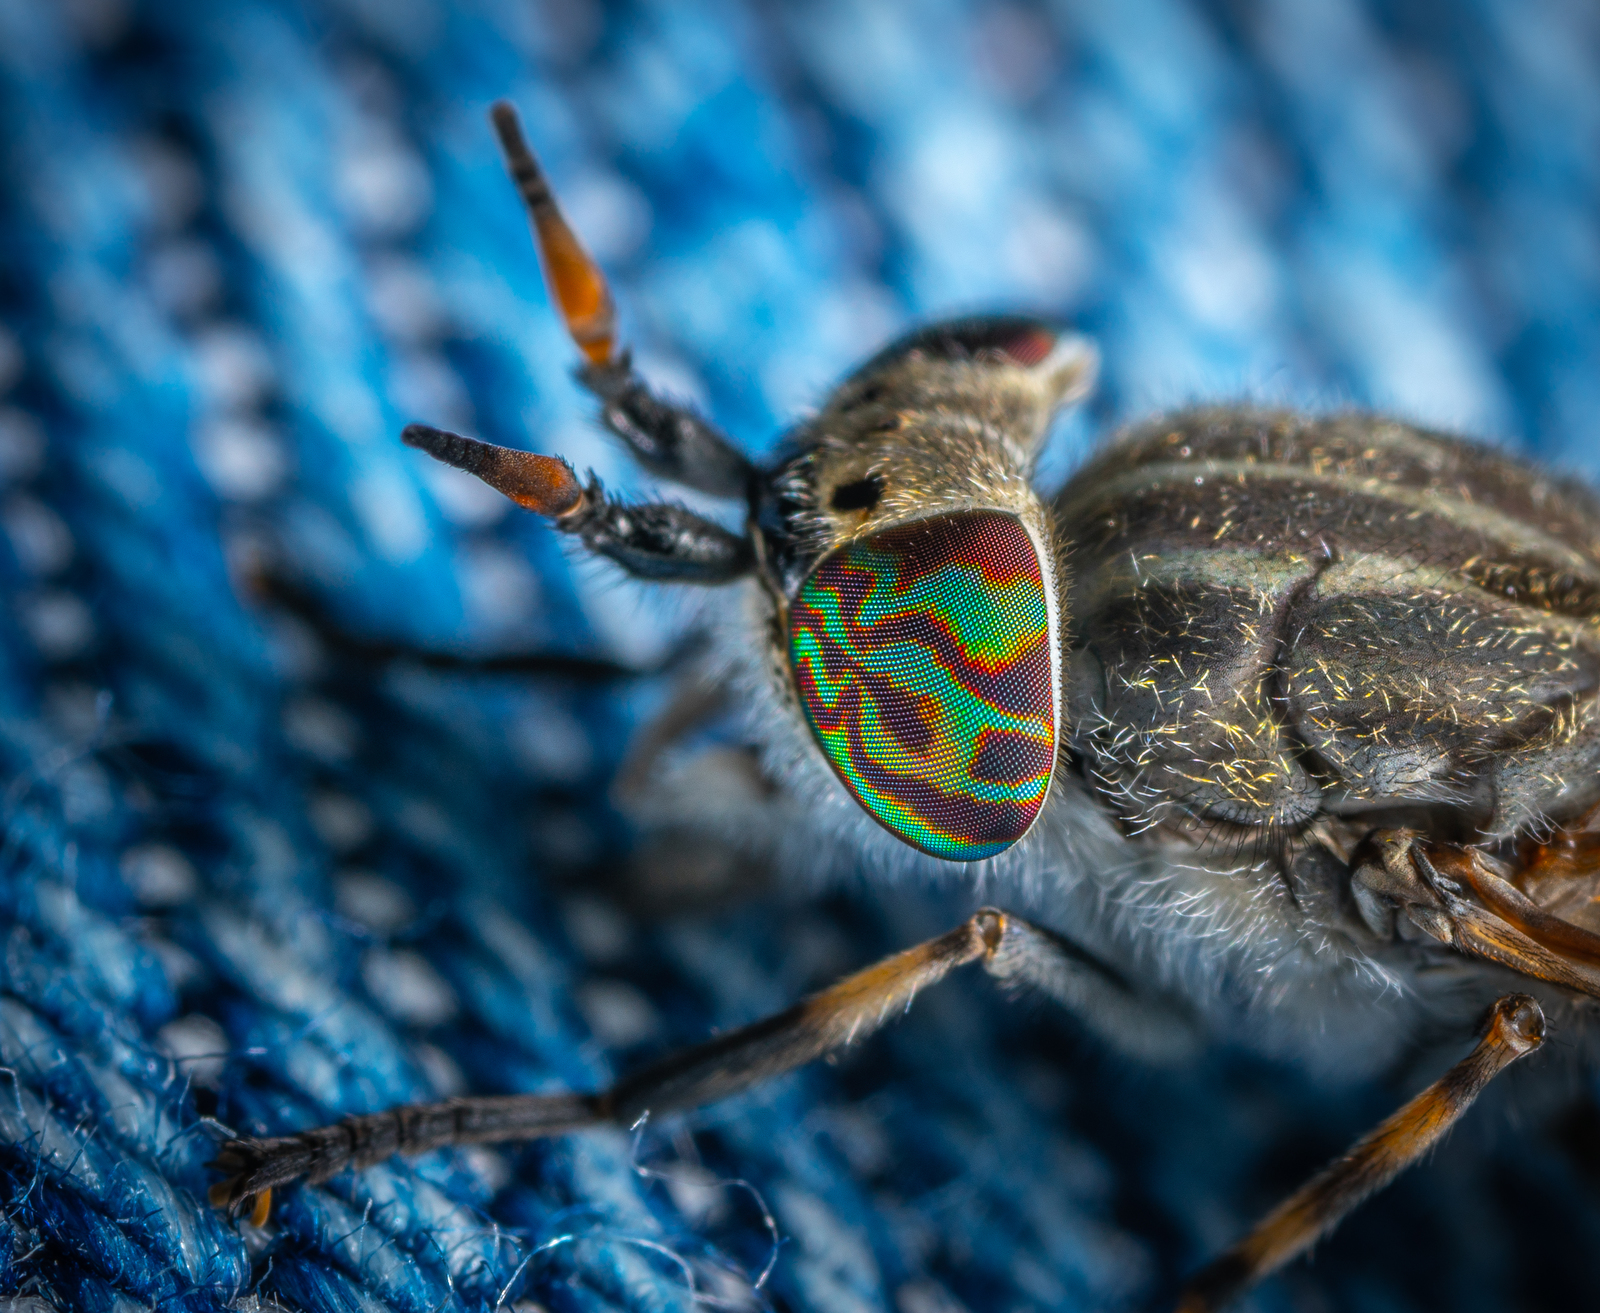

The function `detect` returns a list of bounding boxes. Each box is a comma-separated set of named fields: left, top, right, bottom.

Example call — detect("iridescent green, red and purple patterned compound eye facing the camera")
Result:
left=789, top=510, right=1056, bottom=862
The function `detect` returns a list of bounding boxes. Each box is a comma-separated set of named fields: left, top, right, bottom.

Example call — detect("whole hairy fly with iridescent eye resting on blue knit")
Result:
left=211, top=104, right=1600, bottom=1310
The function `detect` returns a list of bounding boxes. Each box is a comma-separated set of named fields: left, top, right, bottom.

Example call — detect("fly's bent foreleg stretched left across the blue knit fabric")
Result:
left=210, top=908, right=1190, bottom=1215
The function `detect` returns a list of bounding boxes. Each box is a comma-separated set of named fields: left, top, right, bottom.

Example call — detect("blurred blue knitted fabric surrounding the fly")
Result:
left=0, top=0, right=1600, bottom=1313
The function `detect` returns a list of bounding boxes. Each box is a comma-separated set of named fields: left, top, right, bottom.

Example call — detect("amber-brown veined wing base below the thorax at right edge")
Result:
left=1350, top=830, right=1600, bottom=998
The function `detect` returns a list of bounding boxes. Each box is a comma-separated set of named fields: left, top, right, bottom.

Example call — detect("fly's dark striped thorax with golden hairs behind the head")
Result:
left=1056, top=409, right=1600, bottom=833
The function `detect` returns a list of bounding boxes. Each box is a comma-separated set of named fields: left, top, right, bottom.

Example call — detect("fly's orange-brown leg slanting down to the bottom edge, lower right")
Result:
left=1178, top=993, right=1544, bottom=1313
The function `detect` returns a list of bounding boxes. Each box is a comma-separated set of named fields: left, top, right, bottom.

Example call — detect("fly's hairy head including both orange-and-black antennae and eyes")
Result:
left=405, top=106, right=1098, bottom=860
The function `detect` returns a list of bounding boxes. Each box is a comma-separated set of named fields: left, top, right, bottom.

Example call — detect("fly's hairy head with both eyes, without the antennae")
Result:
left=754, top=318, right=1094, bottom=860
